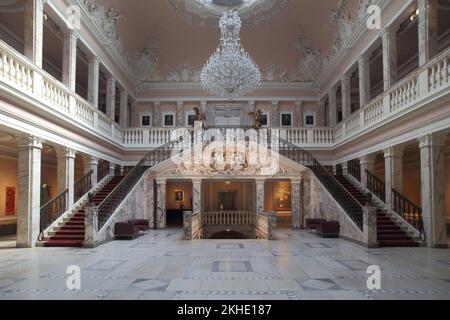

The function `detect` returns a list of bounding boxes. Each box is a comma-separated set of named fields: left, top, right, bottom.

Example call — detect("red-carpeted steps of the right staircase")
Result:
left=335, top=175, right=419, bottom=247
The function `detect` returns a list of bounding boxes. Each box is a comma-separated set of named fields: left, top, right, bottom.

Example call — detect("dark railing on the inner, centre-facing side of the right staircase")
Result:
left=280, top=139, right=363, bottom=230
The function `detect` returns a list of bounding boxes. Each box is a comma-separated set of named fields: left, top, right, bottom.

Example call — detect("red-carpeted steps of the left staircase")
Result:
left=43, top=176, right=124, bottom=247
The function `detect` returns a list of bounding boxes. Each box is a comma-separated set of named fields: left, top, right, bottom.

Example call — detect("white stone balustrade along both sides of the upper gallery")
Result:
left=0, top=40, right=450, bottom=152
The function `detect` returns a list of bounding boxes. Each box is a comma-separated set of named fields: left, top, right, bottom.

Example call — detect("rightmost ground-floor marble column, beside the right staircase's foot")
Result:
left=419, top=134, right=447, bottom=248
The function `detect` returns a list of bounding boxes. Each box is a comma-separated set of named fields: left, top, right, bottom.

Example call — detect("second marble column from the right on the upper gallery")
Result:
left=381, top=25, right=397, bottom=91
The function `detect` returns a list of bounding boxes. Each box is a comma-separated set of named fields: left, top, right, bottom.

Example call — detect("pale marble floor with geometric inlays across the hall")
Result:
left=0, top=230, right=450, bottom=300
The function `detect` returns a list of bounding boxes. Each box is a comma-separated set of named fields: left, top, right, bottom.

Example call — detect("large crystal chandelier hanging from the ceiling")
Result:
left=200, top=10, right=262, bottom=100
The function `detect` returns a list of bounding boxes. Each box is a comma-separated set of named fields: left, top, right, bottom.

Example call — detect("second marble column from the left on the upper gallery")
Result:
left=62, top=30, right=78, bottom=92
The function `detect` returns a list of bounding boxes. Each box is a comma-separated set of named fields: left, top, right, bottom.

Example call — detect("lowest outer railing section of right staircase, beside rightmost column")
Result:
left=392, top=189, right=425, bottom=241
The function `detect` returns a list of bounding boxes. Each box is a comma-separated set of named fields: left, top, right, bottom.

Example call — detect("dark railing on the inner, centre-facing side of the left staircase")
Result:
left=98, top=138, right=182, bottom=231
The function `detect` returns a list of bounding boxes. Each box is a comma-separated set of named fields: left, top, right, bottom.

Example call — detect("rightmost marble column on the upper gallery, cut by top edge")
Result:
left=417, top=0, right=438, bottom=66
